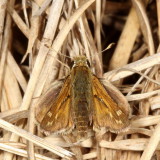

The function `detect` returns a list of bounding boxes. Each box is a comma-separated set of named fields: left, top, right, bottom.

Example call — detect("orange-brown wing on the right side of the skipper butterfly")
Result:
left=92, top=76, right=129, bottom=132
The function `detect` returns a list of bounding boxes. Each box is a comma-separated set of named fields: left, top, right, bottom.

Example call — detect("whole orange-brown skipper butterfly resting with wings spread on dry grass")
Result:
left=36, top=56, right=130, bottom=139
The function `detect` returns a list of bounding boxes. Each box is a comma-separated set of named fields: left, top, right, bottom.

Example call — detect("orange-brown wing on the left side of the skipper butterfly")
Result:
left=36, top=76, right=74, bottom=133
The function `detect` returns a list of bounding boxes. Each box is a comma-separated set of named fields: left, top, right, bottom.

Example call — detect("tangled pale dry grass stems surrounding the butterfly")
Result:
left=0, top=0, right=160, bottom=160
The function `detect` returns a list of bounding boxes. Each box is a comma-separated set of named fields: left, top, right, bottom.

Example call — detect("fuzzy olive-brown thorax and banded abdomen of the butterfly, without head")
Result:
left=71, top=61, right=92, bottom=139
